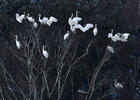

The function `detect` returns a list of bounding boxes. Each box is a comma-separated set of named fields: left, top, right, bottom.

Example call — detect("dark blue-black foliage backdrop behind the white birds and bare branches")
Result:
left=0, top=0, right=140, bottom=100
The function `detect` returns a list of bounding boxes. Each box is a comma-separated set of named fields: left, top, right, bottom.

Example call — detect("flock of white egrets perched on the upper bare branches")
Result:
left=15, top=11, right=130, bottom=58
